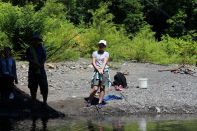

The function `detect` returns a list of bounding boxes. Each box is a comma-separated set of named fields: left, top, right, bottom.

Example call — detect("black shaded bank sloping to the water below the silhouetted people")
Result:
left=0, top=88, right=65, bottom=119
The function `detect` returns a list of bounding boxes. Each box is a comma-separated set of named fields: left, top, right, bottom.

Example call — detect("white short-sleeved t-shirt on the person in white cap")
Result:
left=92, top=51, right=109, bottom=68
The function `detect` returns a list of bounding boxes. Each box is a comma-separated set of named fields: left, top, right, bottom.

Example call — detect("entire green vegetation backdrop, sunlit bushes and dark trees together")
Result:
left=0, top=0, right=197, bottom=64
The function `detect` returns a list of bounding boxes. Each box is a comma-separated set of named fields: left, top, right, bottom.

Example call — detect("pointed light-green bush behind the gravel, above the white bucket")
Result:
left=126, top=26, right=169, bottom=64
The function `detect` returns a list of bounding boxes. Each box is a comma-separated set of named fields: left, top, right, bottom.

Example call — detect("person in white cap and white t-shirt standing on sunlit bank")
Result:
left=87, top=40, right=109, bottom=108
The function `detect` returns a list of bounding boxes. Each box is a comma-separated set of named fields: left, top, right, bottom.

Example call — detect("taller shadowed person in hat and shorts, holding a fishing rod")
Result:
left=27, top=34, right=48, bottom=104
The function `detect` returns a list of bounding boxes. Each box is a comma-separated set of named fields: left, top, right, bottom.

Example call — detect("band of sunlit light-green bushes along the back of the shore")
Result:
left=0, top=0, right=197, bottom=64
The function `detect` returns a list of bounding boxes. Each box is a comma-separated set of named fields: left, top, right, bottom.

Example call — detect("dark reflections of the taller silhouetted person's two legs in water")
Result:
left=30, top=118, right=48, bottom=131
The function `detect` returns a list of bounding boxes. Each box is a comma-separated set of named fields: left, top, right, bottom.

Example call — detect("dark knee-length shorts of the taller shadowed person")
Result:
left=28, top=72, right=48, bottom=95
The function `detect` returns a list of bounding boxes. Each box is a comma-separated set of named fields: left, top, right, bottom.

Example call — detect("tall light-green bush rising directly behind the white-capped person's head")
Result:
left=79, top=4, right=134, bottom=60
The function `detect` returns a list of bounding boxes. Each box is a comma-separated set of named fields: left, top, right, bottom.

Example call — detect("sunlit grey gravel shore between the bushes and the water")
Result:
left=8, top=59, right=197, bottom=116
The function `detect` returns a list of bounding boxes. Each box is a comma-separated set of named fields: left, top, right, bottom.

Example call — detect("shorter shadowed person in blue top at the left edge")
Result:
left=0, top=47, right=18, bottom=99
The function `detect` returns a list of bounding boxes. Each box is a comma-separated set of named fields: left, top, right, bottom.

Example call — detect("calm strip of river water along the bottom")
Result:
left=0, top=116, right=197, bottom=131
